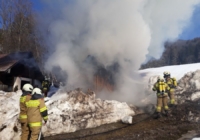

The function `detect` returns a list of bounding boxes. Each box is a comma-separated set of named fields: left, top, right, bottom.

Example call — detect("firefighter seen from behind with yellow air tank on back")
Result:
left=152, top=76, right=170, bottom=118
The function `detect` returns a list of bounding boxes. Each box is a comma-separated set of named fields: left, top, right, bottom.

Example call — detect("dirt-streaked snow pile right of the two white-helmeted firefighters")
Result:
left=42, top=90, right=135, bottom=136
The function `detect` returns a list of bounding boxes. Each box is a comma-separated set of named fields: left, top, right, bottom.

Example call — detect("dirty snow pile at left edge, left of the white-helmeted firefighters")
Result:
left=0, top=90, right=22, bottom=140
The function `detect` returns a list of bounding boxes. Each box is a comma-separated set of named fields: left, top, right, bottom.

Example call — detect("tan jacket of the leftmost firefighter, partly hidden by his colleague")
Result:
left=19, top=91, right=31, bottom=123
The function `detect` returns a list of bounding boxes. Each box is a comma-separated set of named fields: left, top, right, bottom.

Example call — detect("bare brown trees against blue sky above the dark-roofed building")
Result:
left=0, top=0, right=44, bottom=64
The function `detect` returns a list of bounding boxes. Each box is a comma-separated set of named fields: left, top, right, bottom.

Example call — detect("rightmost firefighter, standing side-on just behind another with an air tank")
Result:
left=163, top=71, right=177, bottom=106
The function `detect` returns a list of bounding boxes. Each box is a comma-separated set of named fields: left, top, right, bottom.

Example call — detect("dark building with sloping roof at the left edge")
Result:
left=0, top=52, right=44, bottom=91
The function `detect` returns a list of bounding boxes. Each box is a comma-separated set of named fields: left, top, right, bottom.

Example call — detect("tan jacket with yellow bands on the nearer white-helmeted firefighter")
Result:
left=26, top=94, right=48, bottom=127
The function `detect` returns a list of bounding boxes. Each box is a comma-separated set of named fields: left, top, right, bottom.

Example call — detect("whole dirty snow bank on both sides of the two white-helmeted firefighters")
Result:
left=0, top=90, right=135, bottom=140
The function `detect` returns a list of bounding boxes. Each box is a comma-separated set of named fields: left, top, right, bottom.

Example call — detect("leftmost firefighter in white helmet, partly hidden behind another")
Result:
left=19, top=84, right=33, bottom=140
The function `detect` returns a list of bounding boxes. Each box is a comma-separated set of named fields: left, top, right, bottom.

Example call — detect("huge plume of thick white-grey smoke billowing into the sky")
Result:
left=40, top=0, right=200, bottom=104
